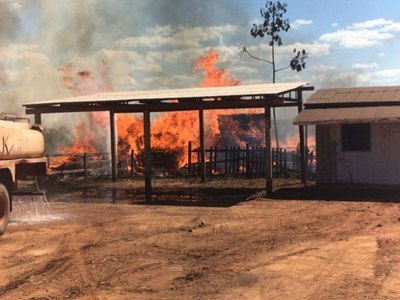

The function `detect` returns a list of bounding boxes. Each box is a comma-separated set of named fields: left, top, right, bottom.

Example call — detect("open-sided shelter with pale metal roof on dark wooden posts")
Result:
left=24, top=82, right=313, bottom=201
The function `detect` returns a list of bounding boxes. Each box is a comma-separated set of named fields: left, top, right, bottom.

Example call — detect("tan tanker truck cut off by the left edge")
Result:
left=0, top=113, right=48, bottom=235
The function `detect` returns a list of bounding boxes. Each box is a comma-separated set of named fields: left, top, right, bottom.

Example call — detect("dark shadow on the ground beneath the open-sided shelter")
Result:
left=42, top=177, right=265, bottom=207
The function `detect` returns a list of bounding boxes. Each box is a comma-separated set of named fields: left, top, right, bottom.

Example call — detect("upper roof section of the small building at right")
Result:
left=305, top=86, right=400, bottom=108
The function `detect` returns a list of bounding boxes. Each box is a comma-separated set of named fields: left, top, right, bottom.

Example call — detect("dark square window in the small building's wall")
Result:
left=342, top=124, right=371, bottom=151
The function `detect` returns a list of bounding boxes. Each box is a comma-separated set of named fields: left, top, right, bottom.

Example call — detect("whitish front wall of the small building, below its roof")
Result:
left=316, top=123, right=400, bottom=185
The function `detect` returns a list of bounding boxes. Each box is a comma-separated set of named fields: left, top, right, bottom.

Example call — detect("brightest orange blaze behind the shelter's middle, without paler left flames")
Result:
left=117, top=49, right=239, bottom=166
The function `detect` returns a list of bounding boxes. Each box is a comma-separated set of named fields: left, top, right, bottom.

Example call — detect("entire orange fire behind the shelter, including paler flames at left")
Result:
left=59, top=49, right=312, bottom=172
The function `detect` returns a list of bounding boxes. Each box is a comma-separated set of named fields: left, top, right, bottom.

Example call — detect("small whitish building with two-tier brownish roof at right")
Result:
left=294, top=86, right=400, bottom=185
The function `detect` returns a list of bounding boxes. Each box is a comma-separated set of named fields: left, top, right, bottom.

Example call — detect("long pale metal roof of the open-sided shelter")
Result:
left=23, top=82, right=307, bottom=108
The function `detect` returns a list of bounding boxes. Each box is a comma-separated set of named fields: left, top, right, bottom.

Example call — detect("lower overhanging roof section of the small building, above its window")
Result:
left=293, top=106, right=400, bottom=125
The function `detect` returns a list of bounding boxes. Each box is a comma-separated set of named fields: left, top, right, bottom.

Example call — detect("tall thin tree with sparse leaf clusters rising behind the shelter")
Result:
left=242, top=1, right=308, bottom=148
